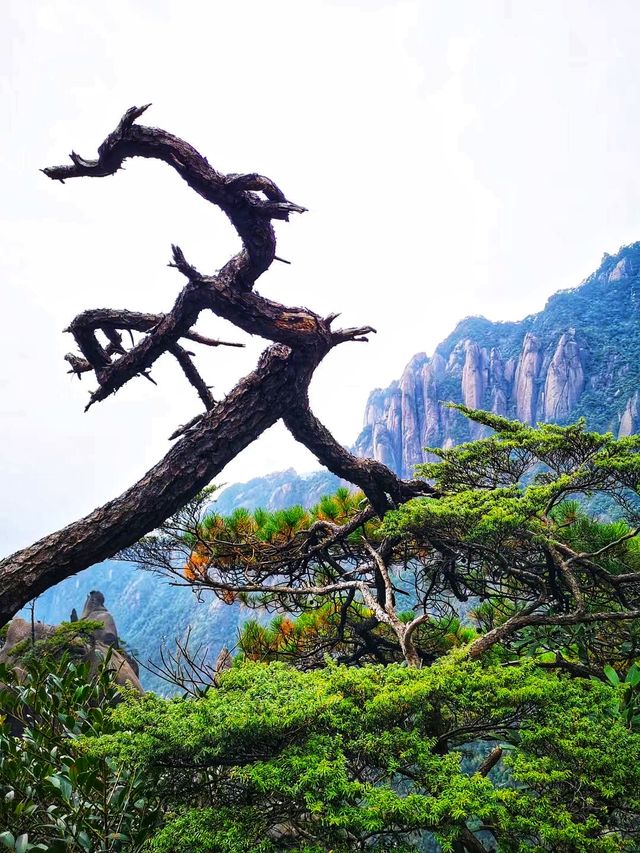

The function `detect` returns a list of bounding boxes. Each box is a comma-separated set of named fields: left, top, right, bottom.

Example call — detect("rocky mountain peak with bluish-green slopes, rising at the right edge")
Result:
left=355, top=243, right=640, bottom=476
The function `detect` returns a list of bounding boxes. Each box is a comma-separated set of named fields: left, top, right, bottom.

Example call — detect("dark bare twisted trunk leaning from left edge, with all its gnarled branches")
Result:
left=0, top=105, right=429, bottom=625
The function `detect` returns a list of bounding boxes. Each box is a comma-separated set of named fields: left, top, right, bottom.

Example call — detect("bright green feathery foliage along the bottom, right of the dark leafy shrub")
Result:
left=83, top=652, right=640, bottom=853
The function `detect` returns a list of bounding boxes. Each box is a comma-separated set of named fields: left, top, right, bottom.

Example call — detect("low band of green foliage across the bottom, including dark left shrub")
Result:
left=0, top=650, right=640, bottom=853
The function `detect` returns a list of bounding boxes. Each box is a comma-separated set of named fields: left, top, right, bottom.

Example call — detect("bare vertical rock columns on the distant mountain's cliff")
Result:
left=355, top=329, right=585, bottom=476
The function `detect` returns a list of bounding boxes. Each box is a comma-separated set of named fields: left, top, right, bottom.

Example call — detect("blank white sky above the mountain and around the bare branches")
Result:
left=0, top=0, right=640, bottom=553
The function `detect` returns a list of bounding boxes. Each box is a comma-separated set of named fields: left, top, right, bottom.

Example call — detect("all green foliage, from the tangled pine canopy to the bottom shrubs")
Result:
left=0, top=409, right=640, bottom=853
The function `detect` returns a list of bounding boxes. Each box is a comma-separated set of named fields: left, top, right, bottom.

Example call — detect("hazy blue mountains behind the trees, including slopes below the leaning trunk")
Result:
left=25, top=238, right=640, bottom=689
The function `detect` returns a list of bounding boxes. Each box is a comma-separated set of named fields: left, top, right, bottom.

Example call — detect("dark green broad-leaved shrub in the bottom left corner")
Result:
left=0, top=648, right=157, bottom=853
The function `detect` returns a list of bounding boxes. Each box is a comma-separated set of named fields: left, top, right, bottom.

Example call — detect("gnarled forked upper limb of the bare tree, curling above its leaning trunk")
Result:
left=43, top=105, right=324, bottom=408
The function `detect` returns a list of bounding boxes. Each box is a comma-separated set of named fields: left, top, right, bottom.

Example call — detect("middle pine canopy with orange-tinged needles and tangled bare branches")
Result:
left=125, top=407, right=640, bottom=666
